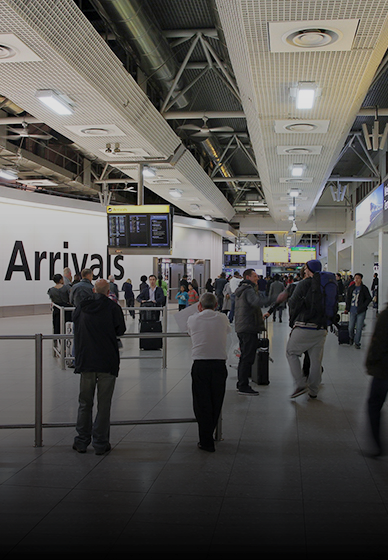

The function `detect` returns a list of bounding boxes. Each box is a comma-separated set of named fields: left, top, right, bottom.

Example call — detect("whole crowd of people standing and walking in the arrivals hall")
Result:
left=48, top=259, right=382, bottom=455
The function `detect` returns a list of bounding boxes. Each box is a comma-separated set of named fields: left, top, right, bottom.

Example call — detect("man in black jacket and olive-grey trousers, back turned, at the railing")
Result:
left=73, top=279, right=126, bottom=455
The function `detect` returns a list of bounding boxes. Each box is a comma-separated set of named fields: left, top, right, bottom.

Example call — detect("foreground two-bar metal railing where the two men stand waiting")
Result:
left=0, top=332, right=222, bottom=447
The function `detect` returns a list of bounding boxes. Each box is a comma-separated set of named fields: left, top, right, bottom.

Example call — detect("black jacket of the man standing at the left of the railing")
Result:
left=73, top=294, right=126, bottom=377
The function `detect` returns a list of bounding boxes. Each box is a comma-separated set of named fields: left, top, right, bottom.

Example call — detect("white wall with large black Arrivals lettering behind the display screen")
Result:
left=0, top=187, right=222, bottom=307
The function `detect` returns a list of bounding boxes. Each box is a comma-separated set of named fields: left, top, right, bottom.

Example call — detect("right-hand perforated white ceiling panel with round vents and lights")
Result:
left=216, top=0, right=388, bottom=227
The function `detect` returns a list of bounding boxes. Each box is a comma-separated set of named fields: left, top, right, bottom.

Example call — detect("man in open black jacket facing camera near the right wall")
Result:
left=345, top=272, right=372, bottom=349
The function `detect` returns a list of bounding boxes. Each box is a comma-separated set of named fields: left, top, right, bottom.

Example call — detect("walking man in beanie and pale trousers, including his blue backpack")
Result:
left=286, top=260, right=338, bottom=399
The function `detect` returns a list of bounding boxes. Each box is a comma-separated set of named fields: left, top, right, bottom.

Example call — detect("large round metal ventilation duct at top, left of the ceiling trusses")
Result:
left=91, top=0, right=189, bottom=109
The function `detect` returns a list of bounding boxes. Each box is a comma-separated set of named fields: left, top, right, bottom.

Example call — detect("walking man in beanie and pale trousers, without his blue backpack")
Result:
left=286, top=259, right=327, bottom=398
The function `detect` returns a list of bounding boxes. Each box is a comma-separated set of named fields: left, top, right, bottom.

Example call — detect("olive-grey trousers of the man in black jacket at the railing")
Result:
left=74, top=372, right=116, bottom=451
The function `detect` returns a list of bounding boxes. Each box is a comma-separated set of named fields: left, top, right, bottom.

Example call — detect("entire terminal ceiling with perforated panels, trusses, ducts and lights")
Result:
left=0, top=0, right=388, bottom=243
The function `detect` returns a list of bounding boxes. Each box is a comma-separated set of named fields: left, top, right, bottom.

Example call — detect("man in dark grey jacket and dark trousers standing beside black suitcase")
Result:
left=234, top=268, right=265, bottom=396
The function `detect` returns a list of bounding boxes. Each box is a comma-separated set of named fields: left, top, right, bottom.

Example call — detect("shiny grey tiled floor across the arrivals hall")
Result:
left=0, top=310, right=388, bottom=559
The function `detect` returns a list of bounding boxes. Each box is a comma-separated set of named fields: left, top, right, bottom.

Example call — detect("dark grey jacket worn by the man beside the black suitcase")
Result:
left=234, top=280, right=265, bottom=333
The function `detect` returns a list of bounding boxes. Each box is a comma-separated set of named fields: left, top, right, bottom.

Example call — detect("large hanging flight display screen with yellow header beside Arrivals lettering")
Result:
left=107, top=205, right=172, bottom=250
